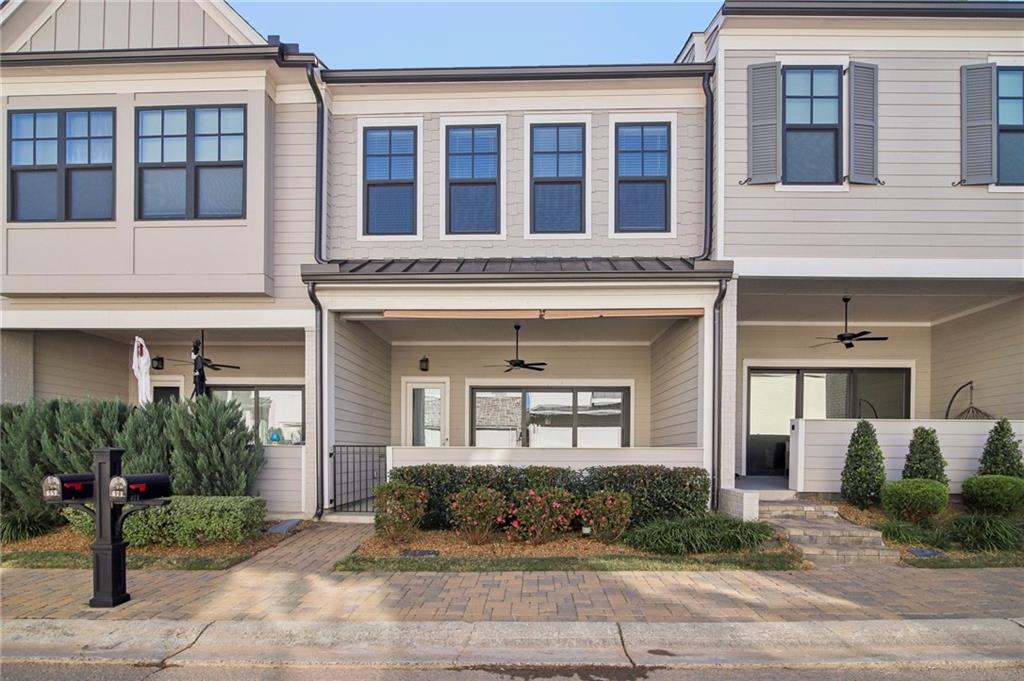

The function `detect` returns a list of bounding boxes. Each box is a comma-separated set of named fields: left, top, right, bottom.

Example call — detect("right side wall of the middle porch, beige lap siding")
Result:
left=650, top=320, right=700, bottom=446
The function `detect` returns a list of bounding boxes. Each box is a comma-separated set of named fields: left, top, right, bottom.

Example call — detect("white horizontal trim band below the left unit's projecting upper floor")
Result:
left=0, top=307, right=313, bottom=330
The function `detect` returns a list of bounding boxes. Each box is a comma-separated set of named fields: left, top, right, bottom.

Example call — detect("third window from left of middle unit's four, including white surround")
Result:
left=522, top=114, right=593, bottom=240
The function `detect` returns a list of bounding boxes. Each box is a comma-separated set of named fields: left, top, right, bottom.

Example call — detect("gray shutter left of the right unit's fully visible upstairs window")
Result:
left=746, top=61, right=782, bottom=184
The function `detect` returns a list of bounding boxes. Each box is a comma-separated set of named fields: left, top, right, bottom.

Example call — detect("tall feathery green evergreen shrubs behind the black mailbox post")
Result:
left=0, top=399, right=263, bottom=541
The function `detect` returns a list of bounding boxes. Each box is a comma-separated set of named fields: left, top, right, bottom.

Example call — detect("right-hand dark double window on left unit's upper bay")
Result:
left=136, top=107, right=246, bottom=219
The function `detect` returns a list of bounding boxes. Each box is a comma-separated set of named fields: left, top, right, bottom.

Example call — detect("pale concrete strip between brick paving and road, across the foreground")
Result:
left=2, top=619, right=1024, bottom=668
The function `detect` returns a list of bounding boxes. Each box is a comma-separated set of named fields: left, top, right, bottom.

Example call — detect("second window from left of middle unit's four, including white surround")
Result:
left=438, top=116, right=508, bottom=241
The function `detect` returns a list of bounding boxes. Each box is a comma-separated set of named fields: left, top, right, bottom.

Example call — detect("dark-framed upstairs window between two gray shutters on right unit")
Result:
left=782, top=67, right=843, bottom=184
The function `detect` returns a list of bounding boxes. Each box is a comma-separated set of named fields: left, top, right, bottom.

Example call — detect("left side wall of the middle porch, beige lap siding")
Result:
left=334, top=320, right=391, bottom=444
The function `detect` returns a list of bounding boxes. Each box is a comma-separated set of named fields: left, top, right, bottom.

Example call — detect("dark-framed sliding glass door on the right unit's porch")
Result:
left=746, top=368, right=910, bottom=475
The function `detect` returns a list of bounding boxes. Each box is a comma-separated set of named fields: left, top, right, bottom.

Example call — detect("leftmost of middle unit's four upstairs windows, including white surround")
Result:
left=355, top=116, right=423, bottom=241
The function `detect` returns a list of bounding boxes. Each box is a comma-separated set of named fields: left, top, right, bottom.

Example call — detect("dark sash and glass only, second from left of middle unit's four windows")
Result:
left=445, top=125, right=501, bottom=235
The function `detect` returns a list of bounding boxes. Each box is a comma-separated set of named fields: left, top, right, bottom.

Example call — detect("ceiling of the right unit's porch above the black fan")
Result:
left=737, top=279, right=1024, bottom=325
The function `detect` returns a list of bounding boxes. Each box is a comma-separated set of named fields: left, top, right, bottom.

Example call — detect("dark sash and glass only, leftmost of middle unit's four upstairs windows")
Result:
left=362, top=128, right=416, bottom=236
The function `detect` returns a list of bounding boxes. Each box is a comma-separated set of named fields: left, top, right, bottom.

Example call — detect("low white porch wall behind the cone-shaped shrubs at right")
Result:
left=790, top=419, right=1024, bottom=494
